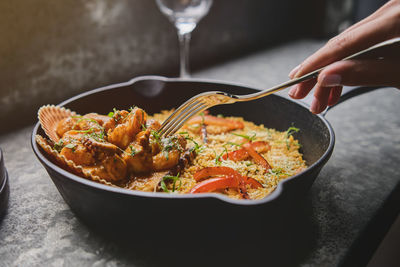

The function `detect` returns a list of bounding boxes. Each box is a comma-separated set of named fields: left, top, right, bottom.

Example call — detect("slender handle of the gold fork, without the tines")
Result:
left=237, top=38, right=400, bottom=101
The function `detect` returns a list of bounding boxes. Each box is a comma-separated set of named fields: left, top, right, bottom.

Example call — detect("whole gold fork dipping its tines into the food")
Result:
left=158, top=38, right=400, bottom=137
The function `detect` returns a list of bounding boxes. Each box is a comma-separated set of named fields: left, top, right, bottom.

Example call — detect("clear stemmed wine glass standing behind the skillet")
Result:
left=156, top=0, right=213, bottom=78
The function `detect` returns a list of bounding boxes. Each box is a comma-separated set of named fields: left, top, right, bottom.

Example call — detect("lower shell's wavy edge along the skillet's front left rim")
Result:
left=35, top=135, right=115, bottom=186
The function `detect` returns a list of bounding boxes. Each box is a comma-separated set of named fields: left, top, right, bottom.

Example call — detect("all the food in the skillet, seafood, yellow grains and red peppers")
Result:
left=36, top=106, right=306, bottom=199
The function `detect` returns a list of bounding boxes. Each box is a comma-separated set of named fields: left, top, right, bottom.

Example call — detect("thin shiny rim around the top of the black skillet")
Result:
left=31, top=76, right=335, bottom=206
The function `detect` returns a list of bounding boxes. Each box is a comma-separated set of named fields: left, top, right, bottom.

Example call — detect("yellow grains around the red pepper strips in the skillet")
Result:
left=149, top=111, right=307, bottom=199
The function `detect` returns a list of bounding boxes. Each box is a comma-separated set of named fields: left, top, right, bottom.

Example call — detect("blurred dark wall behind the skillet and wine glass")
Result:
left=0, top=0, right=323, bottom=132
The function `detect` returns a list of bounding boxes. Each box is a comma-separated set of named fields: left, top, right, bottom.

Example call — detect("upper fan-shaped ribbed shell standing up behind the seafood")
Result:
left=38, top=105, right=77, bottom=143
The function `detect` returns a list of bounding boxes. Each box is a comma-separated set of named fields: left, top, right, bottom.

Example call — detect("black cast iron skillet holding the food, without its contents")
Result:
left=31, top=76, right=382, bottom=231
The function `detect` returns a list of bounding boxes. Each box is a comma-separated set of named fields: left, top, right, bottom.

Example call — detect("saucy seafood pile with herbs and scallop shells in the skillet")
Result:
left=36, top=106, right=192, bottom=185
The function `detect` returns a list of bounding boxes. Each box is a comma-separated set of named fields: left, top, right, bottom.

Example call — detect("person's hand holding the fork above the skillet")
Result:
left=289, top=0, right=400, bottom=114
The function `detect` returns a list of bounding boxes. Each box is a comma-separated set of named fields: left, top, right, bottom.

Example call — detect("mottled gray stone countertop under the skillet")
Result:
left=0, top=40, right=400, bottom=266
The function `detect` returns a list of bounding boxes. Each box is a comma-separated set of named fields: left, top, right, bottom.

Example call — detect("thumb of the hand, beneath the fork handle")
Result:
left=317, top=59, right=400, bottom=88
